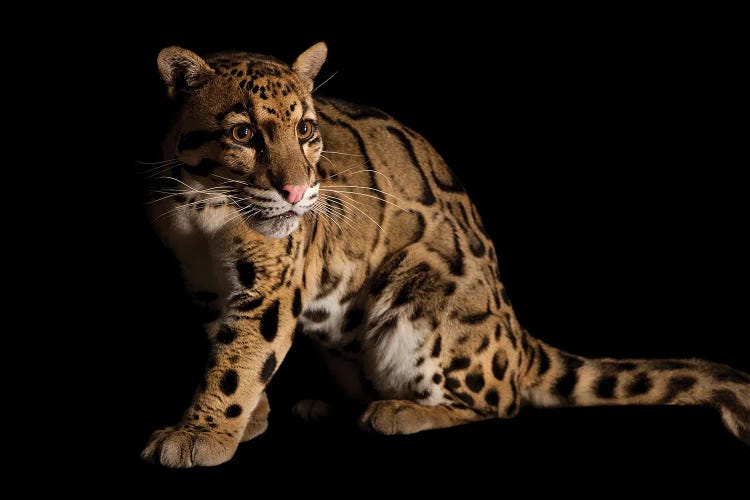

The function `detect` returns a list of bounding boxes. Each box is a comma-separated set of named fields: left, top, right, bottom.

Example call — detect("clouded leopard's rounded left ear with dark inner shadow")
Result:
left=156, top=47, right=215, bottom=97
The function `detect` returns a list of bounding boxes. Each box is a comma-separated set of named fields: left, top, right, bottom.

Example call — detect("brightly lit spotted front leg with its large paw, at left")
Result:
left=142, top=236, right=301, bottom=467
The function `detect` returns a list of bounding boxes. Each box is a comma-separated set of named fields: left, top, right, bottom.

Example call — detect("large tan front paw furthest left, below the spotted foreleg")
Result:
left=141, top=427, right=239, bottom=468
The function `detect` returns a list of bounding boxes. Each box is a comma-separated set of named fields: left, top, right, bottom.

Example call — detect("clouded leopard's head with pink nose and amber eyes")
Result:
left=157, top=42, right=327, bottom=238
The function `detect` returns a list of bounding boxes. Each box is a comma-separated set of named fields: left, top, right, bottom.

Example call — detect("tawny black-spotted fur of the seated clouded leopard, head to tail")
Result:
left=143, top=43, right=750, bottom=467
